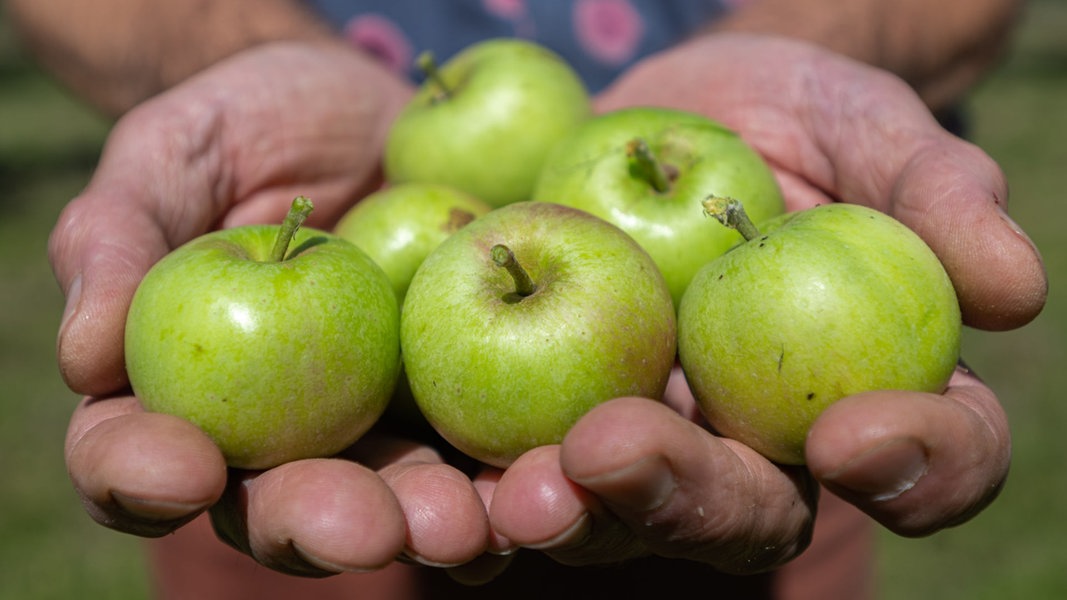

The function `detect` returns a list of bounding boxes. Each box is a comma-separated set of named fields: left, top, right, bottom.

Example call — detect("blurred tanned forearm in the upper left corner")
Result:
left=7, top=0, right=335, bottom=115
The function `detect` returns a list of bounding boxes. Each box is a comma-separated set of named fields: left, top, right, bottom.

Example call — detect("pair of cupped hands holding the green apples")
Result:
left=49, top=34, right=1047, bottom=581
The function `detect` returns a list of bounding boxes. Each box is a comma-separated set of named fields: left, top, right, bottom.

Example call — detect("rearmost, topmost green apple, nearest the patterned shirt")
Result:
left=383, top=38, right=592, bottom=207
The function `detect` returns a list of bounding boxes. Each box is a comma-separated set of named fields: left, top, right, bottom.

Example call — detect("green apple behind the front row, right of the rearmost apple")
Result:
left=534, top=107, right=785, bottom=306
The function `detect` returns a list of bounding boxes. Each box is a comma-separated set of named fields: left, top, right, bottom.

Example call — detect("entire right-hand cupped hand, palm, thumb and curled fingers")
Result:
left=490, top=34, right=1047, bottom=572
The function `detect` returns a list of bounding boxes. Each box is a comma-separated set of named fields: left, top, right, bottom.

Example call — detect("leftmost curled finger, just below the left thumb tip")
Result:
left=65, top=397, right=226, bottom=537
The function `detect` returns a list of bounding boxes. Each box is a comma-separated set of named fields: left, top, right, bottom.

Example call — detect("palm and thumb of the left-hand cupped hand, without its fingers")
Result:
left=50, top=45, right=408, bottom=395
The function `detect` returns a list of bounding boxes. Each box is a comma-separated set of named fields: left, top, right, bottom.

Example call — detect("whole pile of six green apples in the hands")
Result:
left=126, top=40, right=960, bottom=469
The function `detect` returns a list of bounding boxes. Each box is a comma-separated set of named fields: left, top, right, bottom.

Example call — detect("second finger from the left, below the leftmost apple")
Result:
left=211, top=459, right=405, bottom=577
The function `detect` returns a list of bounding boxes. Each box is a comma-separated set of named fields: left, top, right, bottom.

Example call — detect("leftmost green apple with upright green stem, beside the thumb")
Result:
left=126, top=198, right=400, bottom=469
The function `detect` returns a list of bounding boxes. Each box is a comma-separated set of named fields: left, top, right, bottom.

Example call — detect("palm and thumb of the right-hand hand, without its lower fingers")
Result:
left=598, top=33, right=1048, bottom=330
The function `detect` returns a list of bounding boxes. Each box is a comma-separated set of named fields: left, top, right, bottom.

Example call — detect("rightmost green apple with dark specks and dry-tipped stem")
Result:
left=678, top=199, right=961, bottom=464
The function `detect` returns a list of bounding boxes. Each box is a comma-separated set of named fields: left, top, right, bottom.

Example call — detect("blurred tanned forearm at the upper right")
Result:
left=712, top=0, right=1023, bottom=111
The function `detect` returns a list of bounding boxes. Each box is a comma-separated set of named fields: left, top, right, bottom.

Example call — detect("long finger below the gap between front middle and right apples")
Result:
left=560, top=398, right=817, bottom=573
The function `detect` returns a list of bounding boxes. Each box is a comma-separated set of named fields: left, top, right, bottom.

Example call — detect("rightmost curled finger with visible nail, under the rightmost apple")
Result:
left=807, top=369, right=1010, bottom=536
